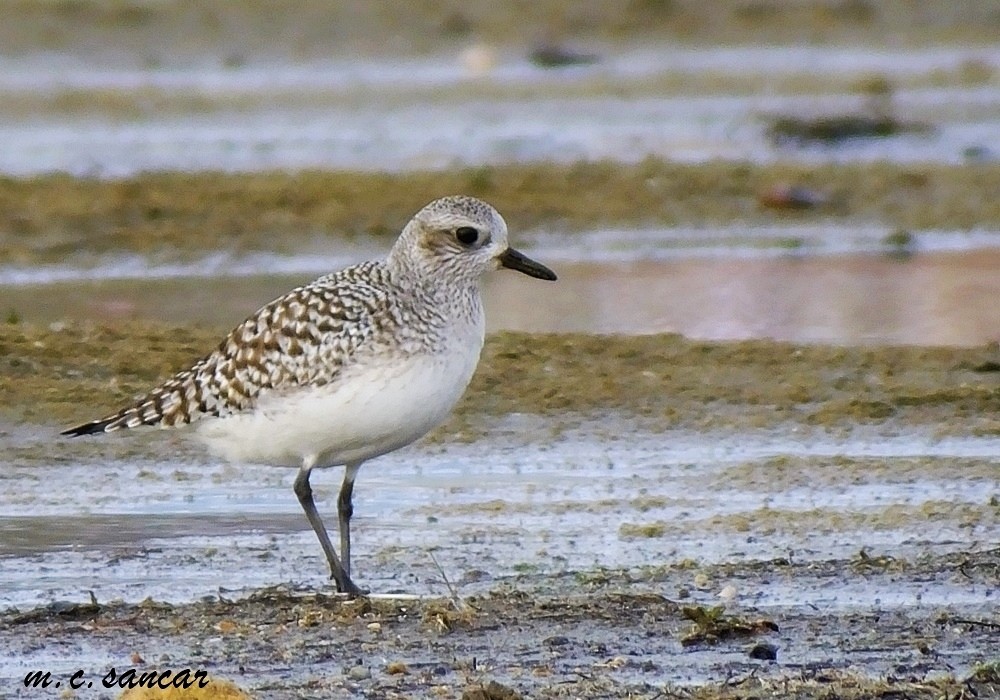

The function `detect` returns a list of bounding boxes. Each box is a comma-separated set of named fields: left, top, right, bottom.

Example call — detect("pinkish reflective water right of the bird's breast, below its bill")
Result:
left=508, top=251, right=1000, bottom=345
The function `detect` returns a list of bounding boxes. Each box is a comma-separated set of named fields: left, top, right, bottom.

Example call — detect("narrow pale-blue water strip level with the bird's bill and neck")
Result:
left=0, top=222, right=1000, bottom=288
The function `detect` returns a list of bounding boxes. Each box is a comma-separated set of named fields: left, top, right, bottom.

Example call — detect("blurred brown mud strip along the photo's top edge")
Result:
left=0, top=0, right=1000, bottom=65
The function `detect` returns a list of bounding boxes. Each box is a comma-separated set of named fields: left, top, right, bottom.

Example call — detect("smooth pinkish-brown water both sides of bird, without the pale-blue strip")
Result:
left=0, top=250, right=1000, bottom=345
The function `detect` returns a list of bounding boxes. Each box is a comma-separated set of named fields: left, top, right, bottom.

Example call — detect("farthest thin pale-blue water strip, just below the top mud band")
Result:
left=0, top=44, right=996, bottom=94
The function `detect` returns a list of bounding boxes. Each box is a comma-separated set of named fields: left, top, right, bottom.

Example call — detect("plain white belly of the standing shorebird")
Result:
left=199, top=349, right=479, bottom=467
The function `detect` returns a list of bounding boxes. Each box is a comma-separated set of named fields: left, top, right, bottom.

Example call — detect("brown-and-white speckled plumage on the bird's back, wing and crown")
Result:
left=62, top=197, right=495, bottom=432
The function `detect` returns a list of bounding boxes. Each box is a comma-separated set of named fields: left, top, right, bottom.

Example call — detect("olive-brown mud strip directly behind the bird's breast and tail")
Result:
left=0, top=322, right=1000, bottom=441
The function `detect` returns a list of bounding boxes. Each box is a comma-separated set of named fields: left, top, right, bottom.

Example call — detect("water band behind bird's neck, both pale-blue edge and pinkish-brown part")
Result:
left=0, top=245, right=1000, bottom=346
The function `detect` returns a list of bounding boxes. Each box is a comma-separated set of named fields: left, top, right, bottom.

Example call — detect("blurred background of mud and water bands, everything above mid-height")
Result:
left=0, top=0, right=1000, bottom=345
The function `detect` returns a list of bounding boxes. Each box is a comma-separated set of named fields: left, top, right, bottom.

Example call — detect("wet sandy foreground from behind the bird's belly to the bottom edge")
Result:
left=0, top=322, right=1000, bottom=698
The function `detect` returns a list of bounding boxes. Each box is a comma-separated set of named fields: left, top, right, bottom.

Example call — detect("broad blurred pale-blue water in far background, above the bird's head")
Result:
left=0, top=45, right=1000, bottom=177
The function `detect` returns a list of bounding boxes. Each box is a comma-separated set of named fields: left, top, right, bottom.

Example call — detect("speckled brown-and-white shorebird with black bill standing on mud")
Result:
left=61, top=195, right=556, bottom=597
